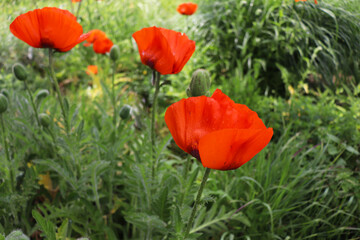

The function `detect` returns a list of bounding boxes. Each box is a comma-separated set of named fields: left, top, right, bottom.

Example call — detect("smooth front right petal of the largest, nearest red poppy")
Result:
left=199, top=128, right=273, bottom=170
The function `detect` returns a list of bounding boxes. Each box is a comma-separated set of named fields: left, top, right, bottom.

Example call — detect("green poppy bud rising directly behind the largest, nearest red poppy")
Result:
left=186, top=69, right=211, bottom=97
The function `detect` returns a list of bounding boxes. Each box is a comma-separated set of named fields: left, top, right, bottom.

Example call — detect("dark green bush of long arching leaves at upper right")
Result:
left=196, top=0, right=360, bottom=96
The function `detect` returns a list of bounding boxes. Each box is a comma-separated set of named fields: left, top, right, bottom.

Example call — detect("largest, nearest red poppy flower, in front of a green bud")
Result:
left=165, top=89, right=273, bottom=170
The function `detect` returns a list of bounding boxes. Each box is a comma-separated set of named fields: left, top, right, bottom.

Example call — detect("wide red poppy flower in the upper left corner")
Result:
left=10, top=7, right=88, bottom=52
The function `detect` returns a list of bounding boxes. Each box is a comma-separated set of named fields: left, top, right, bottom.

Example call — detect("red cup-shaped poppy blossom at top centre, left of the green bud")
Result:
left=132, top=27, right=195, bottom=75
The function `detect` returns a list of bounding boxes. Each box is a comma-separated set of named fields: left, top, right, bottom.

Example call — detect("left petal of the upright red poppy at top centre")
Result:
left=132, top=27, right=175, bottom=75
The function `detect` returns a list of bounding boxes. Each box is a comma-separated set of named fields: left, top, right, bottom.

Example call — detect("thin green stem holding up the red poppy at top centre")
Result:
left=150, top=70, right=160, bottom=178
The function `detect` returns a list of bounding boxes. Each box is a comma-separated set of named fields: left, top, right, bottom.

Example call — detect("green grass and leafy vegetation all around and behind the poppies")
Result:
left=0, top=0, right=360, bottom=240
